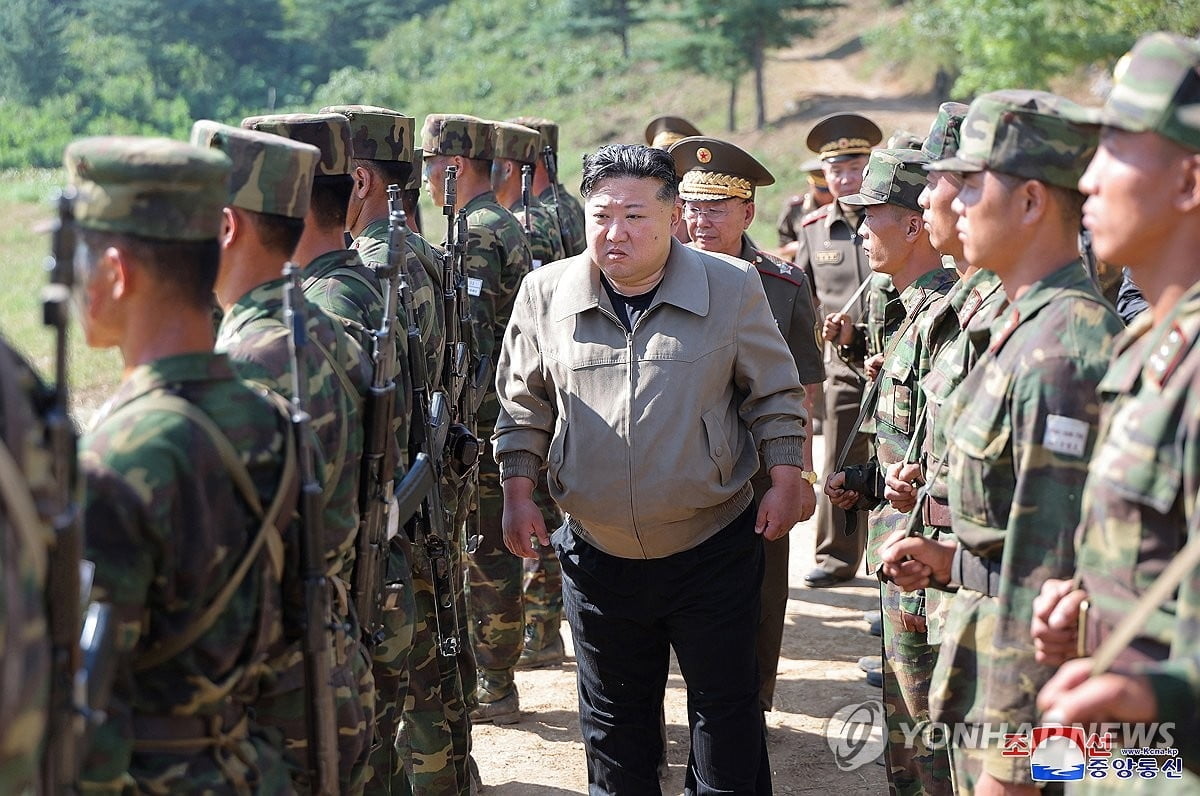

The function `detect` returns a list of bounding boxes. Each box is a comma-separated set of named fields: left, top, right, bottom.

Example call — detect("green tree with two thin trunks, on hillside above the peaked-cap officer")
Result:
left=662, top=0, right=842, bottom=132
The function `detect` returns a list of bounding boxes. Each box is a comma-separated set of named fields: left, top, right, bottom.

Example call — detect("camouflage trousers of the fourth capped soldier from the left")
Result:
left=403, top=475, right=475, bottom=796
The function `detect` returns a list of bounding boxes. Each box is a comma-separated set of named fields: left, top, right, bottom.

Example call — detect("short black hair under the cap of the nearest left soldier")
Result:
left=79, top=228, right=221, bottom=311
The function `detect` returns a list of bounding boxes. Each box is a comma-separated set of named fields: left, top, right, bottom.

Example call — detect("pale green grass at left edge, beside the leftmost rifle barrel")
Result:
left=0, top=169, right=120, bottom=421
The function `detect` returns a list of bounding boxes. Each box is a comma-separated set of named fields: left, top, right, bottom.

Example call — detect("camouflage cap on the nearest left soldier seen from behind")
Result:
left=62, top=136, right=229, bottom=240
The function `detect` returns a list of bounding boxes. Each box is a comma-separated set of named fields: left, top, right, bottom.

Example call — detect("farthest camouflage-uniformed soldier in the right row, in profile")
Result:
left=826, top=149, right=955, bottom=794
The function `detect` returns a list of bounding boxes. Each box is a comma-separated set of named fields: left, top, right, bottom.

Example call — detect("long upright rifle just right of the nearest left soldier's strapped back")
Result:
left=283, top=262, right=338, bottom=794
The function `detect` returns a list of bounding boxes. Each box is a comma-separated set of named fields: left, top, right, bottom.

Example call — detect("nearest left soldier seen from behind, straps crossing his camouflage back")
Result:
left=64, top=137, right=292, bottom=794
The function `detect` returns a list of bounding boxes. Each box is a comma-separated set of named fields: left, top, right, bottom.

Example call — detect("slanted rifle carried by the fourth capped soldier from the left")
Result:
left=388, top=186, right=460, bottom=657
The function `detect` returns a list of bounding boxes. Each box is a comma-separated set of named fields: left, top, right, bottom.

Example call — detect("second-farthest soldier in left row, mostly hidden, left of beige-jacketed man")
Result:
left=484, top=121, right=566, bottom=669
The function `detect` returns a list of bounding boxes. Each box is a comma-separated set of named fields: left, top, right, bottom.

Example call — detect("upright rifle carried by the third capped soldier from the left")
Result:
left=352, top=188, right=408, bottom=646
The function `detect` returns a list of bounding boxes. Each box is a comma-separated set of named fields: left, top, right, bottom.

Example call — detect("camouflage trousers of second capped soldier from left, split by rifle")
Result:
left=254, top=627, right=376, bottom=794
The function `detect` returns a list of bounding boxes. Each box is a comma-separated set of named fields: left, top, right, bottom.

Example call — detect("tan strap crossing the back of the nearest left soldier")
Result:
left=110, top=393, right=296, bottom=671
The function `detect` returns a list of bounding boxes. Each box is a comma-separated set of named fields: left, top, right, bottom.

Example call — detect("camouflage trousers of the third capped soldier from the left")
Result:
left=365, top=531, right=416, bottom=796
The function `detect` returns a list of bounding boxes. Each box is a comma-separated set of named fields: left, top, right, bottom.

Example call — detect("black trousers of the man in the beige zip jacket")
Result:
left=553, top=504, right=770, bottom=796
